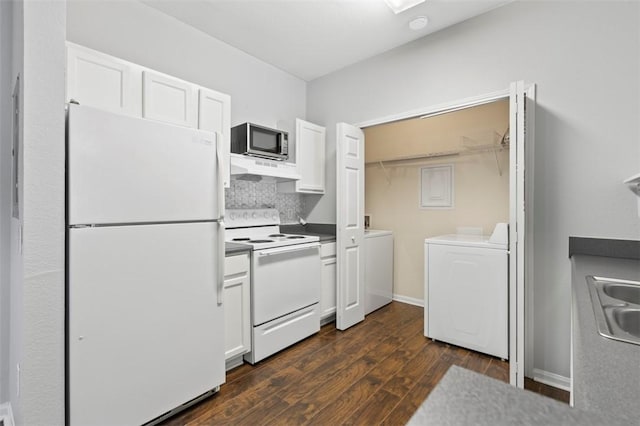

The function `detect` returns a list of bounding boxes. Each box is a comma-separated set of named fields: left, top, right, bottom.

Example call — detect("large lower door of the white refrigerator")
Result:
left=67, top=223, right=225, bottom=426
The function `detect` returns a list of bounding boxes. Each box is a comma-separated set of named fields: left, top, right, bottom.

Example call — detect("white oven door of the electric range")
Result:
left=251, top=242, right=321, bottom=326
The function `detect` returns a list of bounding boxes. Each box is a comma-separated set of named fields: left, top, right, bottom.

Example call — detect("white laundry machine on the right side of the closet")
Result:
left=424, top=227, right=508, bottom=359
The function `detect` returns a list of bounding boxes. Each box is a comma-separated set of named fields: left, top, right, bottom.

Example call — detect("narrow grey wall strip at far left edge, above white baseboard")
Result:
left=0, top=2, right=13, bottom=402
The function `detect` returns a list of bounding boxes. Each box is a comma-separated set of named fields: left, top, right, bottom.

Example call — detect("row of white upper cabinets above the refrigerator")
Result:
left=66, top=42, right=231, bottom=188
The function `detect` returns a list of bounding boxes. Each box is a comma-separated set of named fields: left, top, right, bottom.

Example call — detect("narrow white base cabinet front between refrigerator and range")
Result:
left=224, top=253, right=251, bottom=360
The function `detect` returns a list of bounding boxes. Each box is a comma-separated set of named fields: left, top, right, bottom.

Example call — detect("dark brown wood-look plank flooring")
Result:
left=163, top=302, right=569, bottom=426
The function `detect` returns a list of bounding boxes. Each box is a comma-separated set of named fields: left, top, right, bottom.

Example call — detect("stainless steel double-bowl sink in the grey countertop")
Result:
left=587, top=275, right=640, bottom=345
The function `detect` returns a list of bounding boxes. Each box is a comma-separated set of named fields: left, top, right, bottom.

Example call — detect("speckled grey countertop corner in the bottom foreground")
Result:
left=408, top=366, right=630, bottom=426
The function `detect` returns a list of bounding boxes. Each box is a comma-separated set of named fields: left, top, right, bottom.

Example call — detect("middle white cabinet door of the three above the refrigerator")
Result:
left=142, top=71, right=198, bottom=127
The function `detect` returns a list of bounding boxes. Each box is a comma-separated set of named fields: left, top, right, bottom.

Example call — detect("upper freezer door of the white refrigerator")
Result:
left=67, top=104, right=224, bottom=225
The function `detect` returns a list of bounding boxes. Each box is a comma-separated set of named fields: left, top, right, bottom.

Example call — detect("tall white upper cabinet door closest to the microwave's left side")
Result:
left=198, top=89, right=231, bottom=188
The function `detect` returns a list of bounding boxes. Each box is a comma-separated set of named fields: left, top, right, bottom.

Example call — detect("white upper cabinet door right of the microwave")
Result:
left=296, top=118, right=326, bottom=194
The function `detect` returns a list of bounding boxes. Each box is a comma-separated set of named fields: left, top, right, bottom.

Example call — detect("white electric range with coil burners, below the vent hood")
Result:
left=225, top=209, right=321, bottom=364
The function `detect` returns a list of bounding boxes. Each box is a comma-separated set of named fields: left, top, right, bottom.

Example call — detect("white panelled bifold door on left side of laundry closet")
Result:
left=336, top=123, right=364, bottom=330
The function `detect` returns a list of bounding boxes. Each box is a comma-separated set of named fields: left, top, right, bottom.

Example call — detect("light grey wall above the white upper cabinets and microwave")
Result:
left=67, top=0, right=306, bottom=132
